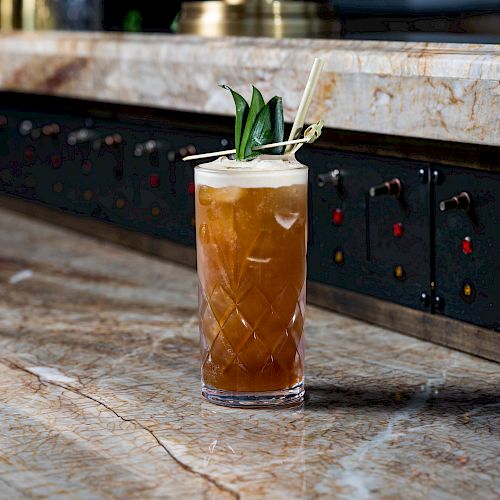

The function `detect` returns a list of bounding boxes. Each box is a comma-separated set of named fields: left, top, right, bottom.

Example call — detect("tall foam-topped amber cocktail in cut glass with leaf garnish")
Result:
left=185, top=60, right=320, bottom=407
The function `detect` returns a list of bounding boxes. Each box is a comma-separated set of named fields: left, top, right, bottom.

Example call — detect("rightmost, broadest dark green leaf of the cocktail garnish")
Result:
left=243, top=96, right=285, bottom=159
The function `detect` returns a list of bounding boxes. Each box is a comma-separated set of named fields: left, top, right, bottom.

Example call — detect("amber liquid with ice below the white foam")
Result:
left=196, top=178, right=307, bottom=392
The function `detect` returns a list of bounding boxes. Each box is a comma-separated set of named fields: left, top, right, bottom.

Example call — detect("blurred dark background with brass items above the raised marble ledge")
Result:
left=0, top=0, right=500, bottom=43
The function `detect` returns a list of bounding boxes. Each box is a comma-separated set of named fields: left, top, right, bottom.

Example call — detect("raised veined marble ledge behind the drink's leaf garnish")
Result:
left=0, top=32, right=500, bottom=146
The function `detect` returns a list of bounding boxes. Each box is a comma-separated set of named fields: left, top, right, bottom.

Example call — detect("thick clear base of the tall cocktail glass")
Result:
left=201, top=382, right=305, bottom=408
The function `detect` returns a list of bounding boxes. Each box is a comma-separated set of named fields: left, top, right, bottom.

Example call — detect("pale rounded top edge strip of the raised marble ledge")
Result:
left=0, top=32, right=500, bottom=81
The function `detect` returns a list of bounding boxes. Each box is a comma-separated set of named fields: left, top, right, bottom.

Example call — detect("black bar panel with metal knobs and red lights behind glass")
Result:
left=0, top=94, right=500, bottom=358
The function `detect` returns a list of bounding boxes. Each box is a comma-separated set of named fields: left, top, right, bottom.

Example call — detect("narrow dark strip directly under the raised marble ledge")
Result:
left=0, top=92, right=500, bottom=171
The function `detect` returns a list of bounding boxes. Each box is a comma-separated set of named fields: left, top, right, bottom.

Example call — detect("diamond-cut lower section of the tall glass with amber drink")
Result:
left=200, top=283, right=305, bottom=383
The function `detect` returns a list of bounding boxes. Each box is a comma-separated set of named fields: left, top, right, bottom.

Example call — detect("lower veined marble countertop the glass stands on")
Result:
left=0, top=205, right=500, bottom=500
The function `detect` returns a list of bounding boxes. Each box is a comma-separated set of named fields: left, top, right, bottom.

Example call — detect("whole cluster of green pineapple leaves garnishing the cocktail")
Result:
left=223, top=85, right=285, bottom=160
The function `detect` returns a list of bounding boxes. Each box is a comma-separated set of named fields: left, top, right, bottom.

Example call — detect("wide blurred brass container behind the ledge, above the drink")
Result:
left=179, top=0, right=340, bottom=38
